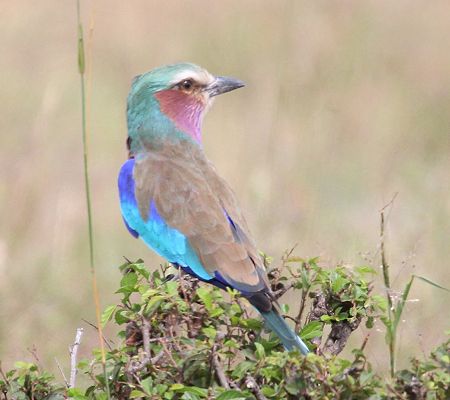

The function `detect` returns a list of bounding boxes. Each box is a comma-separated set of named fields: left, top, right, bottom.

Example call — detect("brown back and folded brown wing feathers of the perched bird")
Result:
left=134, top=143, right=267, bottom=293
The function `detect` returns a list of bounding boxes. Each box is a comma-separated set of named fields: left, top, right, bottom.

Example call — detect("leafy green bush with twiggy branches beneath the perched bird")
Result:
left=0, top=256, right=450, bottom=400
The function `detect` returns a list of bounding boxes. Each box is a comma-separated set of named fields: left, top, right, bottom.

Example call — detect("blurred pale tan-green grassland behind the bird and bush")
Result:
left=0, top=0, right=450, bottom=376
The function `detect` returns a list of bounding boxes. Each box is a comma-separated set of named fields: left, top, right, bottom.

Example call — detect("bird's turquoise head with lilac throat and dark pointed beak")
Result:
left=128, top=63, right=244, bottom=152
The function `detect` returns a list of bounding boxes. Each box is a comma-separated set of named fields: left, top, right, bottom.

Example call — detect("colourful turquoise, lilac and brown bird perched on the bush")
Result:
left=118, top=63, right=309, bottom=354
